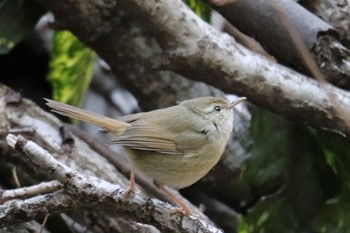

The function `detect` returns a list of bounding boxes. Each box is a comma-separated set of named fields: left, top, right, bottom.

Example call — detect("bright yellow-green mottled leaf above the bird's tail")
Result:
left=48, top=31, right=96, bottom=106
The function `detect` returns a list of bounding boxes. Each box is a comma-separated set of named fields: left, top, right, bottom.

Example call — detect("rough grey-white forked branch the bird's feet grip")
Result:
left=0, top=134, right=220, bottom=232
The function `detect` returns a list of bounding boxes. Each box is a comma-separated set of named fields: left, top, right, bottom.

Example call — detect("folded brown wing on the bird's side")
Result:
left=111, top=110, right=212, bottom=154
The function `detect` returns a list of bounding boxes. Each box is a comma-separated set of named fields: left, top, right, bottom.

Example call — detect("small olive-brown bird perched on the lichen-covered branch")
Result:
left=46, top=97, right=246, bottom=213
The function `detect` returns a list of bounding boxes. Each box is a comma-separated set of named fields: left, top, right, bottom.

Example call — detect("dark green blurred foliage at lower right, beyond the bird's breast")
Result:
left=237, top=109, right=340, bottom=233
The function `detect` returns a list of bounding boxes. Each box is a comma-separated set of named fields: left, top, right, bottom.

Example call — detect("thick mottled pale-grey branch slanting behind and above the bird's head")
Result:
left=34, top=0, right=350, bottom=136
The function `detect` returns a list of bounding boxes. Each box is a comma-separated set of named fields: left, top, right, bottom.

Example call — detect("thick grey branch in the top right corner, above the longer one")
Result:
left=207, top=0, right=350, bottom=90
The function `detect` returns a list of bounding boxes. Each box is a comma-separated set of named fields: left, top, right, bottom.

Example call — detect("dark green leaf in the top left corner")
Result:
left=0, top=0, right=45, bottom=54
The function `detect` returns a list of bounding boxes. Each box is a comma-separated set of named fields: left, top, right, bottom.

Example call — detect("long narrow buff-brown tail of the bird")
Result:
left=45, top=99, right=130, bottom=135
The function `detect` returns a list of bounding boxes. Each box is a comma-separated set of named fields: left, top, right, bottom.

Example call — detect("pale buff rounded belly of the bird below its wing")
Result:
left=127, top=149, right=221, bottom=189
